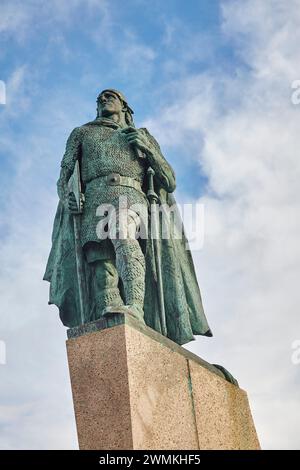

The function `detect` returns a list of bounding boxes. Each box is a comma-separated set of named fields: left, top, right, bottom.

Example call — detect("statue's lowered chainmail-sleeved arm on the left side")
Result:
left=57, top=127, right=81, bottom=203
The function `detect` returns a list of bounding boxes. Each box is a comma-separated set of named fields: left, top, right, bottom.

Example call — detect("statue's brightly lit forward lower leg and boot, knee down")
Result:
left=106, top=239, right=145, bottom=322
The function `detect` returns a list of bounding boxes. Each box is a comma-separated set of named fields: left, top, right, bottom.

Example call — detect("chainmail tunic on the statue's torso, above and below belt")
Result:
left=81, top=126, right=147, bottom=248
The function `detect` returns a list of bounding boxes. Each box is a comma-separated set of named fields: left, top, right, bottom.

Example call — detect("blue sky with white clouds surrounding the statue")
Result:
left=0, top=0, right=300, bottom=448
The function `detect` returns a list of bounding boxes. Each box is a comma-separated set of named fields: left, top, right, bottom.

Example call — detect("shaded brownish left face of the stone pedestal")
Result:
left=67, top=326, right=132, bottom=449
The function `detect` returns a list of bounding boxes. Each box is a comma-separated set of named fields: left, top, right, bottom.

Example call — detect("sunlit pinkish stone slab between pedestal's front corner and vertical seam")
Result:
left=125, top=327, right=198, bottom=449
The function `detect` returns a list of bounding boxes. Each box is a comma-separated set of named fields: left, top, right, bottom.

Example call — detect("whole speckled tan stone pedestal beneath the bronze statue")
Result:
left=67, top=315, right=259, bottom=450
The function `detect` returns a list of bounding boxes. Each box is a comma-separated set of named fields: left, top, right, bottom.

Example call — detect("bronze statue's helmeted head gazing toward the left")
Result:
left=97, top=89, right=133, bottom=126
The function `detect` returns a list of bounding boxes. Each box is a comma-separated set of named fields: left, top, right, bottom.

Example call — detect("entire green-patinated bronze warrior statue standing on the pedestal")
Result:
left=44, top=90, right=212, bottom=345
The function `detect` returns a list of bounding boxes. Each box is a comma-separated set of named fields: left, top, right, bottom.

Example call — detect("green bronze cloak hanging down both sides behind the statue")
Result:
left=44, top=132, right=212, bottom=345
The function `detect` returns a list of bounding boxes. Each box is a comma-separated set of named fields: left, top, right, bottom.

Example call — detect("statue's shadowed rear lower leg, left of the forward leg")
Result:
left=94, top=259, right=124, bottom=319
